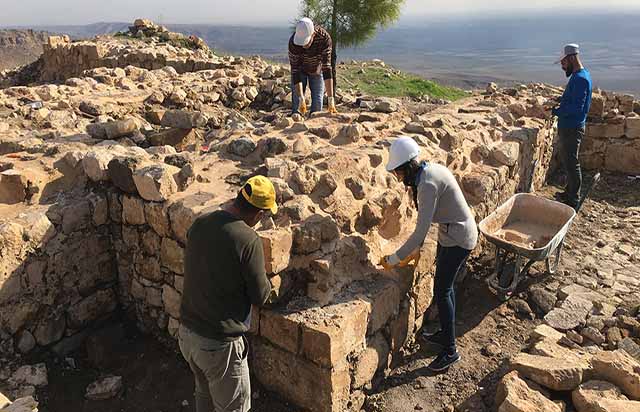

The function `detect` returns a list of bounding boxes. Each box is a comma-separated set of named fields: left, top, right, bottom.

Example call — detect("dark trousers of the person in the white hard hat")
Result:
left=433, top=244, right=471, bottom=353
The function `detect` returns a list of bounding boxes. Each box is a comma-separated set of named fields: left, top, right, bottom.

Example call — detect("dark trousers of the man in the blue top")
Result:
left=558, top=126, right=584, bottom=206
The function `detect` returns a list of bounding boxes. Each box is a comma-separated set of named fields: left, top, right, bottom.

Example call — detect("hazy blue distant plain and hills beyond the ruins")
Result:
left=2, top=13, right=640, bottom=95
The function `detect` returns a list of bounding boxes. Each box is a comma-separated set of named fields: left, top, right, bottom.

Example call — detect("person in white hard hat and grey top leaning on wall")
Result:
left=380, top=136, right=478, bottom=371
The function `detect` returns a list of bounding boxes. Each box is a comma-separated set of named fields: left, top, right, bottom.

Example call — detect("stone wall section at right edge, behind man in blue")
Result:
left=580, top=92, right=640, bottom=175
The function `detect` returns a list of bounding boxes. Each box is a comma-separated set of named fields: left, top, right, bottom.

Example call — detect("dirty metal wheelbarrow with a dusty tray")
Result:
left=478, top=173, right=600, bottom=301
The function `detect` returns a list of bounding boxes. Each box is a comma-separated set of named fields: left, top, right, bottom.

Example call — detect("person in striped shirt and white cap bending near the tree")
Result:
left=289, top=17, right=337, bottom=115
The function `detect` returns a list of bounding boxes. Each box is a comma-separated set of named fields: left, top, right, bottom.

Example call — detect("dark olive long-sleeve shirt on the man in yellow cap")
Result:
left=180, top=210, right=271, bottom=341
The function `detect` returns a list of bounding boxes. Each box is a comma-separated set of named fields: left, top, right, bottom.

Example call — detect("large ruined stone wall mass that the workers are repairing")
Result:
left=0, top=18, right=636, bottom=411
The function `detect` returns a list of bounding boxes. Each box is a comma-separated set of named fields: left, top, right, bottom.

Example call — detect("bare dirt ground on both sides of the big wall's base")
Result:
left=40, top=171, right=640, bottom=412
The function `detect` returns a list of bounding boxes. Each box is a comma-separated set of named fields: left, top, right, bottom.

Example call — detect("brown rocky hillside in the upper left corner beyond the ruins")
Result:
left=0, top=30, right=48, bottom=70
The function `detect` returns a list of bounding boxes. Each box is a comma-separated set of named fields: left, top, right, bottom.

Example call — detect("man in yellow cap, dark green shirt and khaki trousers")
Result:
left=178, top=176, right=278, bottom=412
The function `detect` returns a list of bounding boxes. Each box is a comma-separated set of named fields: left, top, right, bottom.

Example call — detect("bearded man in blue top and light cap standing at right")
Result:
left=552, top=44, right=592, bottom=207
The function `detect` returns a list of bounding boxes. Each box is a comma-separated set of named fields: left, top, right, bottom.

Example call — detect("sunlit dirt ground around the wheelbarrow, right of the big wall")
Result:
left=365, top=175, right=640, bottom=412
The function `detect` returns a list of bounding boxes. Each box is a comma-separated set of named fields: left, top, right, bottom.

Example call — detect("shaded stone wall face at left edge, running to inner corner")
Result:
left=0, top=192, right=118, bottom=355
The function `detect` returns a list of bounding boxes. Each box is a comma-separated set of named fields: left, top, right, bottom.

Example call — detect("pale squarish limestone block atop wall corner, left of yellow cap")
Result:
left=133, top=164, right=180, bottom=202
